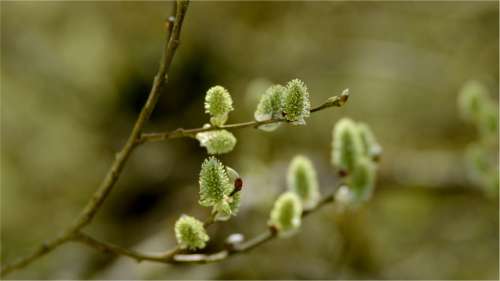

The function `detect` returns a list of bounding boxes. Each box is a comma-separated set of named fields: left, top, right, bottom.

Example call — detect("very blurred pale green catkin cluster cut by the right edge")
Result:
left=458, top=81, right=499, bottom=197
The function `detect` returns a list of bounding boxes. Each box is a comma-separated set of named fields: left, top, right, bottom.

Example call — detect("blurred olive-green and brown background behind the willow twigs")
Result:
left=0, top=1, right=499, bottom=279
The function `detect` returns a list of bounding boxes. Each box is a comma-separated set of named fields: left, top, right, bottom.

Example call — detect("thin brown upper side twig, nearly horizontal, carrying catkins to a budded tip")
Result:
left=138, top=89, right=349, bottom=143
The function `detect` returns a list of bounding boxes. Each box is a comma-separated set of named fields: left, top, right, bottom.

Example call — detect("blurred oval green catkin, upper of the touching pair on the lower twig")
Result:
left=287, top=155, right=320, bottom=209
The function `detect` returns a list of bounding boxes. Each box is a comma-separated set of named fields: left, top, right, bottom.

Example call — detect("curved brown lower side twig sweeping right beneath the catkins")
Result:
left=64, top=191, right=335, bottom=264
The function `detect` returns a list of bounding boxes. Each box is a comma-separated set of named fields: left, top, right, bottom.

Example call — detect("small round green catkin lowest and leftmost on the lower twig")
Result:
left=175, top=215, right=209, bottom=250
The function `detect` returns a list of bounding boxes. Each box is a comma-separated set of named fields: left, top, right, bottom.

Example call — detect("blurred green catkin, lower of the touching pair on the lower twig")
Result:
left=268, top=192, right=302, bottom=237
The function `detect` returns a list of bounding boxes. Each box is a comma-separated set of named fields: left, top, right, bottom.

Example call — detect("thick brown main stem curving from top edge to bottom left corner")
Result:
left=0, top=1, right=188, bottom=276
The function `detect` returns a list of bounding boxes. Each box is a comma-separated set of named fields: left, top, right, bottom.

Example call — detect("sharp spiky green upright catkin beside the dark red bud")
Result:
left=199, top=157, right=233, bottom=207
